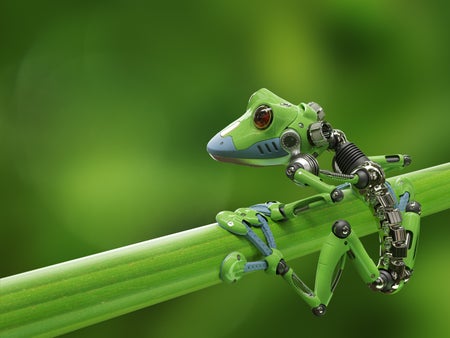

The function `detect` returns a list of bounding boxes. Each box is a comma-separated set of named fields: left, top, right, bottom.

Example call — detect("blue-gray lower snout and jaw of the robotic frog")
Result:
left=206, top=133, right=289, bottom=166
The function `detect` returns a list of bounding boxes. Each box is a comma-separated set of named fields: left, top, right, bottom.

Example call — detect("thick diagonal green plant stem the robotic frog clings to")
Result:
left=0, top=163, right=450, bottom=337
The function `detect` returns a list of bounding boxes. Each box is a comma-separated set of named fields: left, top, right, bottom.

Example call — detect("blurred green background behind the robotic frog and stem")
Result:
left=0, top=0, right=450, bottom=338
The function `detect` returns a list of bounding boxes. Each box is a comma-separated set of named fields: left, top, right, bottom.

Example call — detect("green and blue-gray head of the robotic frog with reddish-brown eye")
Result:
left=207, top=89, right=331, bottom=166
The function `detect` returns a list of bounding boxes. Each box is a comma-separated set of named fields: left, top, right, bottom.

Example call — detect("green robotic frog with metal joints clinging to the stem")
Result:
left=207, top=89, right=421, bottom=316
